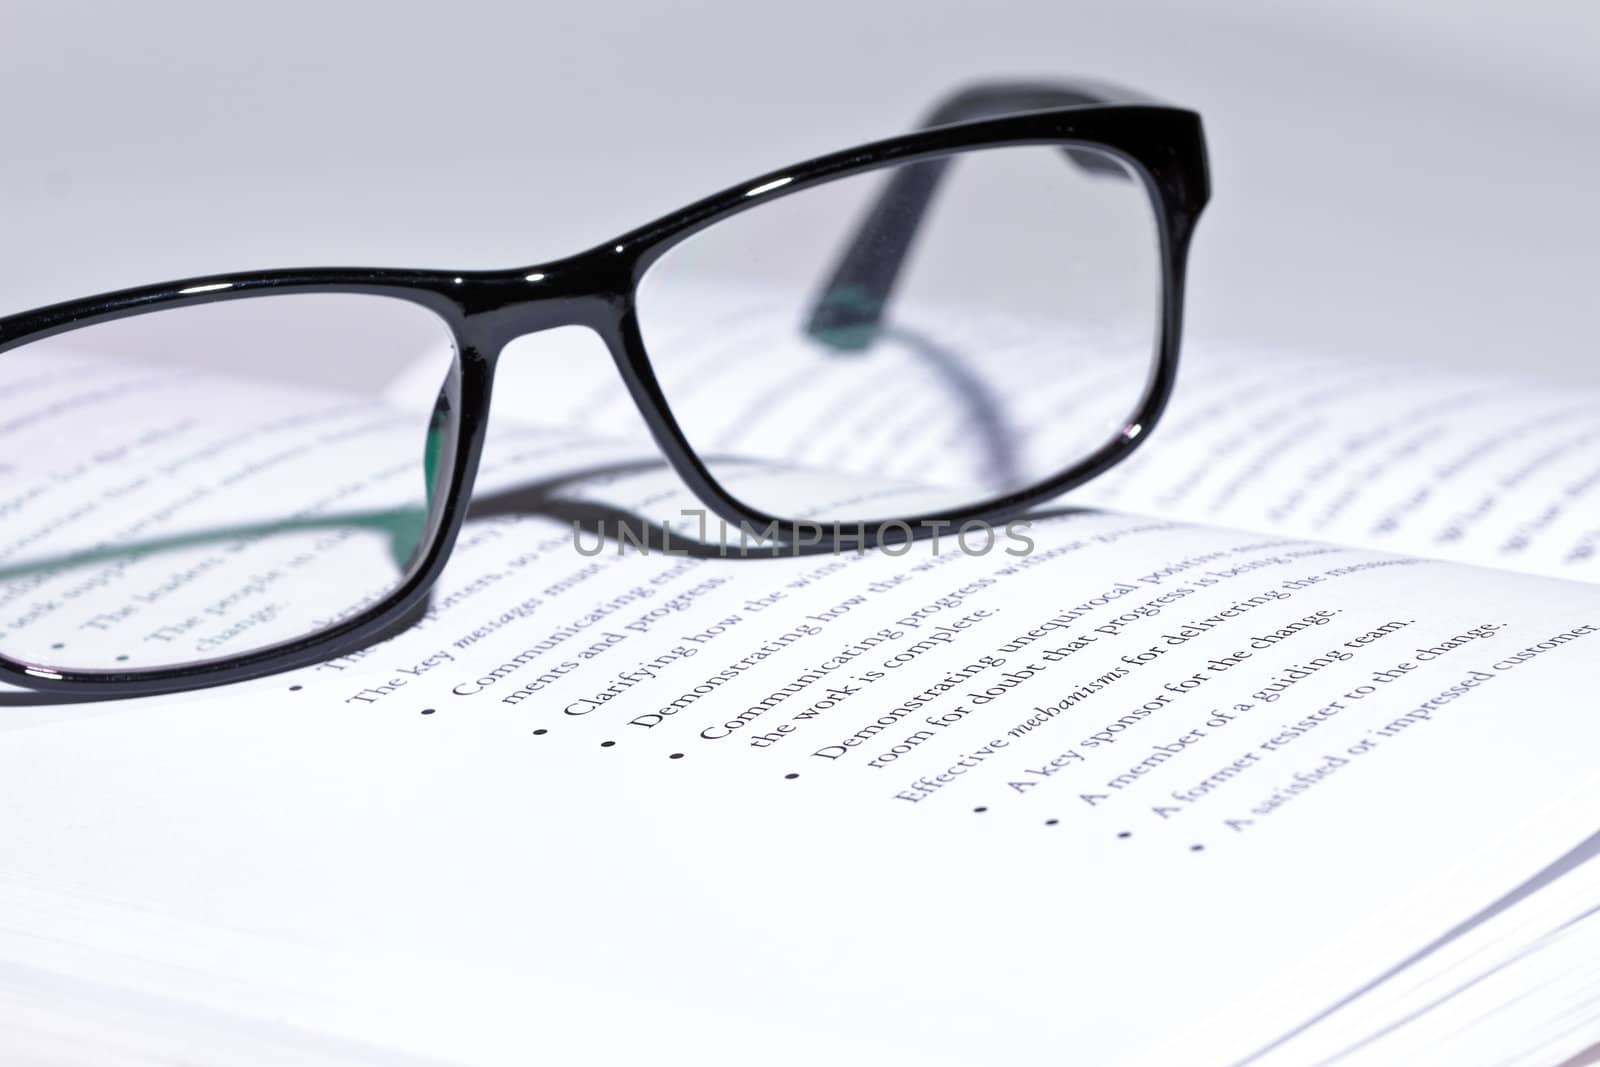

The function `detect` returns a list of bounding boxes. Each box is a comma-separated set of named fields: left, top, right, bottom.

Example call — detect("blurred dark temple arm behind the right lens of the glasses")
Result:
left=805, top=80, right=1154, bottom=352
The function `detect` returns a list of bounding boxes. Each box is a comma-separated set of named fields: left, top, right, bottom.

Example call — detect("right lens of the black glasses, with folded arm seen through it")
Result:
left=638, top=146, right=1162, bottom=523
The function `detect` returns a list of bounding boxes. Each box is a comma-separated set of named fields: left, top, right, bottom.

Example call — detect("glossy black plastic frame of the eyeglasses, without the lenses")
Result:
left=0, top=82, right=1210, bottom=697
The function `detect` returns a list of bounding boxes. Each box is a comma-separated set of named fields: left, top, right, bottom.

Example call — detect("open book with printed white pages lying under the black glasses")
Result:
left=0, top=286, right=1600, bottom=1065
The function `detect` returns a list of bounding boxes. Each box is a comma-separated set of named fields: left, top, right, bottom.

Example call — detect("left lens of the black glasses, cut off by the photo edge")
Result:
left=0, top=294, right=458, bottom=672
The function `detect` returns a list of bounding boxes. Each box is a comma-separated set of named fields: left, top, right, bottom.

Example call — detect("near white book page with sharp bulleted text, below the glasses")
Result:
left=0, top=438, right=1600, bottom=1064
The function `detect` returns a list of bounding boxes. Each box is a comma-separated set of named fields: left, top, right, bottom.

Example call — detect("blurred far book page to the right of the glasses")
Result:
left=1078, top=337, right=1600, bottom=581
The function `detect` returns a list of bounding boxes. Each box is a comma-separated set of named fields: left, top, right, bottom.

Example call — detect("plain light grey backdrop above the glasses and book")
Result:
left=0, top=0, right=1600, bottom=381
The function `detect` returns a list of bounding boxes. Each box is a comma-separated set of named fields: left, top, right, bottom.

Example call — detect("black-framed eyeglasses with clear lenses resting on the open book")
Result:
left=0, top=83, right=1208, bottom=696
